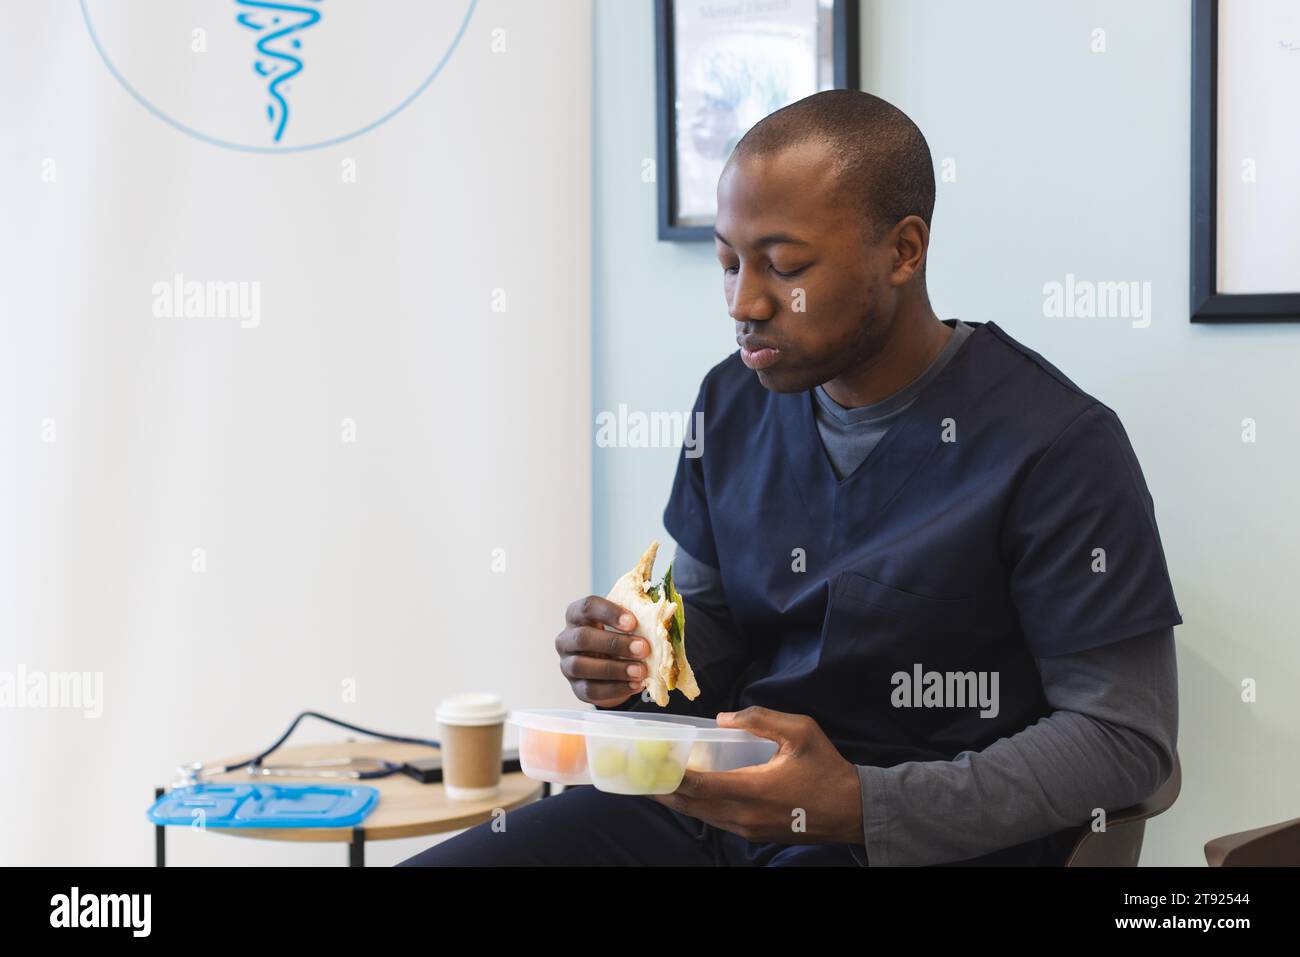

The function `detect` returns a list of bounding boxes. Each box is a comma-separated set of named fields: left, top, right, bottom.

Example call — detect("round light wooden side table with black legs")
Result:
left=153, top=740, right=550, bottom=867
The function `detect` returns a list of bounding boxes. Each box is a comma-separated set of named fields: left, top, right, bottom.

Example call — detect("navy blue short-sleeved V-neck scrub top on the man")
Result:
left=663, top=322, right=1183, bottom=767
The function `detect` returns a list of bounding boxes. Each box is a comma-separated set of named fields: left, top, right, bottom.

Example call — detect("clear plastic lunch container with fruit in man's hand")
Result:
left=507, top=709, right=776, bottom=794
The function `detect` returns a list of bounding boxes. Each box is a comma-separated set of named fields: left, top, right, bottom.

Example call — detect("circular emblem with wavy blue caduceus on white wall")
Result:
left=79, top=0, right=476, bottom=152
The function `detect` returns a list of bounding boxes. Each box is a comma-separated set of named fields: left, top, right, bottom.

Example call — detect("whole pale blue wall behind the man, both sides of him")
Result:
left=593, top=0, right=1300, bottom=865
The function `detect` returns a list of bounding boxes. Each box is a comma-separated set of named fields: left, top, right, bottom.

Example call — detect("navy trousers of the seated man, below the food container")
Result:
left=398, top=784, right=859, bottom=867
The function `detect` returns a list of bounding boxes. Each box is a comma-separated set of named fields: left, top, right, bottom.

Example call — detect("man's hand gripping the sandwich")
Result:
left=555, top=594, right=650, bottom=707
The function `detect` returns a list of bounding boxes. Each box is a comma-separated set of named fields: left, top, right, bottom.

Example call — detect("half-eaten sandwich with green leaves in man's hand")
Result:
left=606, top=542, right=699, bottom=707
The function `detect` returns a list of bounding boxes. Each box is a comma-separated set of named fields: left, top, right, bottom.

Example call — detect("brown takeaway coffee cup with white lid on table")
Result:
left=438, top=694, right=506, bottom=801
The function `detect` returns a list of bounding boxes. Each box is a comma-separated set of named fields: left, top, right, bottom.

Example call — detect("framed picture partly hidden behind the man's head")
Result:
left=655, top=0, right=859, bottom=241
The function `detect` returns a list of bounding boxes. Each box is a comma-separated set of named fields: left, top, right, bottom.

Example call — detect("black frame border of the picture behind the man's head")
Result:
left=655, top=0, right=861, bottom=242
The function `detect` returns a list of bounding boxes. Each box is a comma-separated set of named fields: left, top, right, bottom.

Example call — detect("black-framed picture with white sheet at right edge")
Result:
left=1191, top=0, right=1300, bottom=322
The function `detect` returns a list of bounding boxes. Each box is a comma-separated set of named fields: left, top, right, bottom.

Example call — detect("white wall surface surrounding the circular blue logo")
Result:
left=0, top=0, right=592, bottom=865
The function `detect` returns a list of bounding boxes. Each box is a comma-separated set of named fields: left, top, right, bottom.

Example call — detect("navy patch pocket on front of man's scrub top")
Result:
left=818, top=572, right=982, bottom=763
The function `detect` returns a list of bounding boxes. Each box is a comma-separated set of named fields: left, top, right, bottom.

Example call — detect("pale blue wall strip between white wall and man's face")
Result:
left=592, top=0, right=736, bottom=594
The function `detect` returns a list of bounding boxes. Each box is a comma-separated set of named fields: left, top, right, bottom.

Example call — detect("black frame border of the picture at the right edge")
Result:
left=1188, top=0, right=1300, bottom=322
